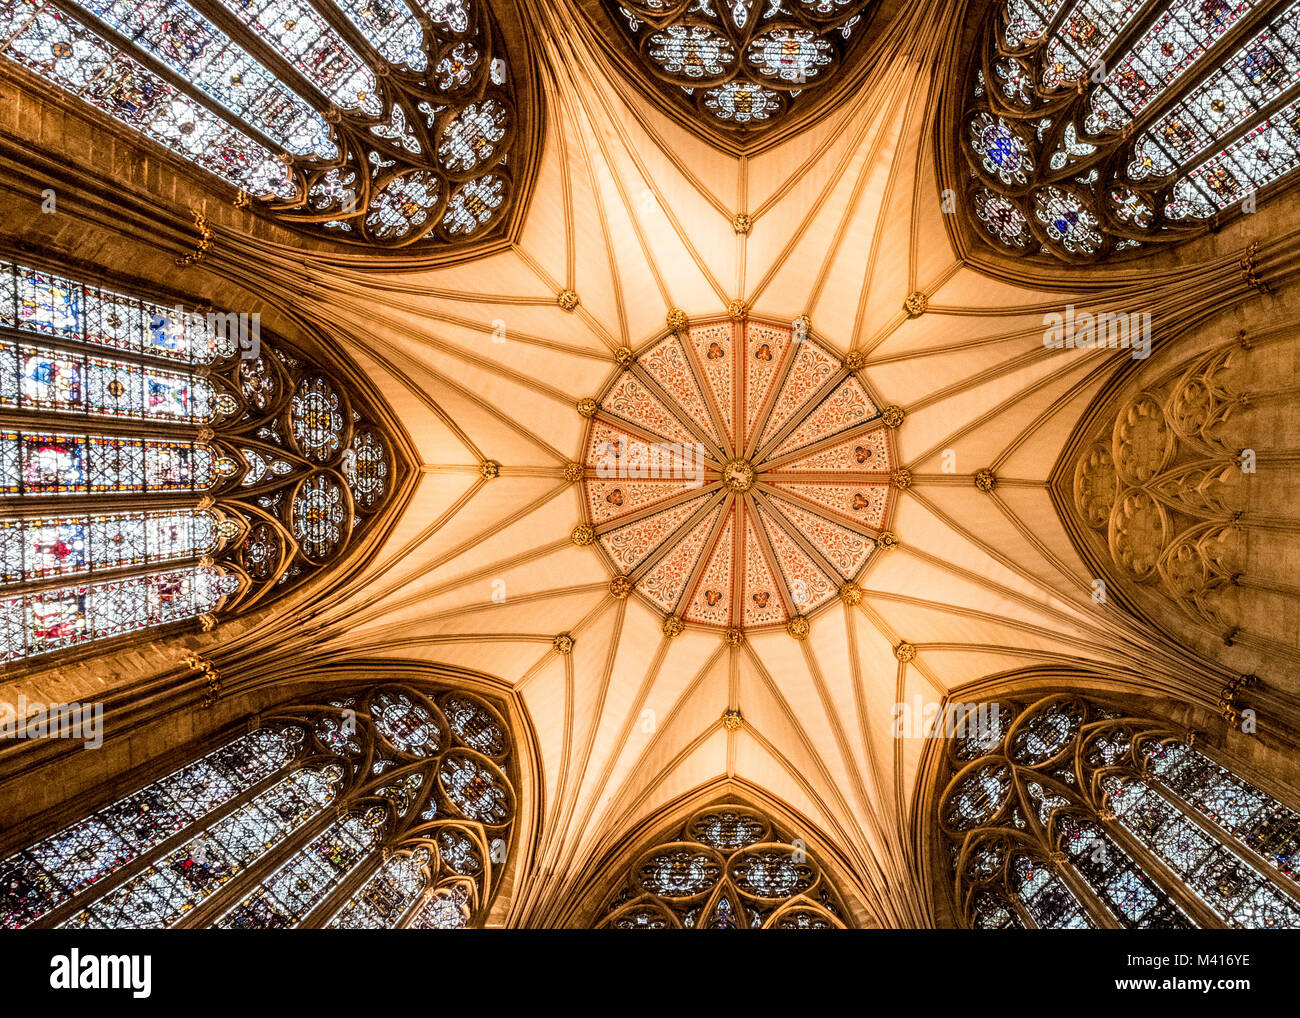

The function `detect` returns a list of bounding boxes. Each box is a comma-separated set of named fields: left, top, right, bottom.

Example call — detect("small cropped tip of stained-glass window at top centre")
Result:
left=605, top=0, right=875, bottom=138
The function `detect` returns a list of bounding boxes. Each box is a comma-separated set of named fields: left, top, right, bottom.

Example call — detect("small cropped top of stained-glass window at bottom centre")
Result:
left=599, top=803, right=852, bottom=930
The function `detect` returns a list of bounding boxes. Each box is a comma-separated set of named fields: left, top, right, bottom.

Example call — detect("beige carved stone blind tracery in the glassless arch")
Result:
left=1074, top=347, right=1247, bottom=629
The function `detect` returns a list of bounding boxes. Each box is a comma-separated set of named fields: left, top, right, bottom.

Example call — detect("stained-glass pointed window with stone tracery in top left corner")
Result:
left=0, top=0, right=517, bottom=247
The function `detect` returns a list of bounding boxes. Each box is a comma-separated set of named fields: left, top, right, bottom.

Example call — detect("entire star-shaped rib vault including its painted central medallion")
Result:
left=0, top=4, right=1294, bottom=926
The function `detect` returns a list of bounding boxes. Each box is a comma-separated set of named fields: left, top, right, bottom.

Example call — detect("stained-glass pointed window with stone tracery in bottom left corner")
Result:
left=0, top=684, right=515, bottom=930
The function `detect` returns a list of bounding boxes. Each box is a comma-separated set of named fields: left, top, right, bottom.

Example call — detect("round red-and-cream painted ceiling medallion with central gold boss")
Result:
left=581, top=317, right=896, bottom=631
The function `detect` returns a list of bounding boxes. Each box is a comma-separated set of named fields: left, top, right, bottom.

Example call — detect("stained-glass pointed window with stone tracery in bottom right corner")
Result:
left=939, top=694, right=1300, bottom=928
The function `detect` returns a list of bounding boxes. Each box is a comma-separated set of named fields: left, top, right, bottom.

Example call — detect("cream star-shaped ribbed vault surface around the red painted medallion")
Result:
left=256, top=4, right=1206, bottom=926
